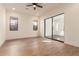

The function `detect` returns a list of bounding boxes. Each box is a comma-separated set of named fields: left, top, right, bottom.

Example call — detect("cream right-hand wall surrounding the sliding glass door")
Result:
left=40, top=4, right=79, bottom=47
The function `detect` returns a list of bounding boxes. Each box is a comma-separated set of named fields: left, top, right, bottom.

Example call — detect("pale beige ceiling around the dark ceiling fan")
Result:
left=3, top=3, right=65, bottom=16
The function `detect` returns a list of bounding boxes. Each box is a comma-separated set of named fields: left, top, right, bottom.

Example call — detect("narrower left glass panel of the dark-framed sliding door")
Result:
left=44, top=18, right=52, bottom=38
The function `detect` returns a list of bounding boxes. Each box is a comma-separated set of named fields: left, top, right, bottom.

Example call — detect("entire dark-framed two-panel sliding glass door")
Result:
left=44, top=13, right=64, bottom=41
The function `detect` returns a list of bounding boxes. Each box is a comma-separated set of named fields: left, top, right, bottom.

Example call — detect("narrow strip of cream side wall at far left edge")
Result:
left=0, top=4, right=6, bottom=46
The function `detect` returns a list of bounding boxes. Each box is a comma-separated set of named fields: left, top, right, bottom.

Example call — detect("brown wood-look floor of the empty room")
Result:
left=0, top=38, right=79, bottom=56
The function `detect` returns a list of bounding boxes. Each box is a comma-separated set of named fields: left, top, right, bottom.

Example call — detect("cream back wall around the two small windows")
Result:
left=7, top=10, right=38, bottom=39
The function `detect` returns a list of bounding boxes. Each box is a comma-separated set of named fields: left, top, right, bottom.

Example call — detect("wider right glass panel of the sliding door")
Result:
left=52, top=14, right=64, bottom=41
